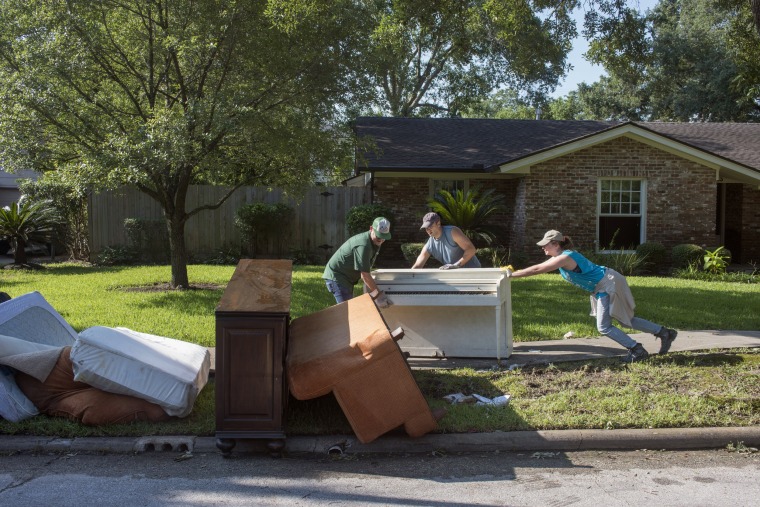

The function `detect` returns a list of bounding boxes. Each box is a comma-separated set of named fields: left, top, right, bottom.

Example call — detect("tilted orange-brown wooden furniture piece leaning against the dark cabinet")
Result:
left=286, top=294, right=437, bottom=443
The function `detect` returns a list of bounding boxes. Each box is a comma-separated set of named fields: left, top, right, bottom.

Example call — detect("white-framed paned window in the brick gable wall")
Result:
left=597, top=179, right=646, bottom=251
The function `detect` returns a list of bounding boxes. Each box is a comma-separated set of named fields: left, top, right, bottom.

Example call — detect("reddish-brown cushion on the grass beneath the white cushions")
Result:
left=16, top=347, right=171, bottom=426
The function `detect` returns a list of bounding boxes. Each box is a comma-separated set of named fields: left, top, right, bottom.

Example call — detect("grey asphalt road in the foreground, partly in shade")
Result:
left=0, top=449, right=760, bottom=507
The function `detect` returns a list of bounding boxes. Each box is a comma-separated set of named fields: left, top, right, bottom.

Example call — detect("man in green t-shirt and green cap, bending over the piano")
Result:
left=322, top=217, right=391, bottom=308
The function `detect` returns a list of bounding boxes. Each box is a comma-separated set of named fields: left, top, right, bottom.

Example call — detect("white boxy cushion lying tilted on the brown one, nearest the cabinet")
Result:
left=71, top=326, right=211, bottom=417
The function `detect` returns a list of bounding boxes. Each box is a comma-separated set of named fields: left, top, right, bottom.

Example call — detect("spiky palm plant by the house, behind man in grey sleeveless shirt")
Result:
left=428, top=188, right=506, bottom=246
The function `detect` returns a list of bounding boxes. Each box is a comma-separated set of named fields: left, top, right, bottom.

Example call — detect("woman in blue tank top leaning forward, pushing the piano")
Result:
left=507, top=230, right=678, bottom=363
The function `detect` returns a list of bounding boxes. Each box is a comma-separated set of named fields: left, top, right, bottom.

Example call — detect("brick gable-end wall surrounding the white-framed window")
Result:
left=515, top=138, right=718, bottom=261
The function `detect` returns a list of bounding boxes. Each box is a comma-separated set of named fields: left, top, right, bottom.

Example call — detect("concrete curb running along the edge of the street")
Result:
left=0, top=426, right=760, bottom=455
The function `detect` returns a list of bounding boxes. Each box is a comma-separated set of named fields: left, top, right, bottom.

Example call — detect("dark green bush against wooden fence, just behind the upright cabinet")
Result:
left=235, top=202, right=295, bottom=256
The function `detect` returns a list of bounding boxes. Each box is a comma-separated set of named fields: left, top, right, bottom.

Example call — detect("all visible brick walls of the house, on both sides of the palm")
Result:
left=374, top=138, right=724, bottom=262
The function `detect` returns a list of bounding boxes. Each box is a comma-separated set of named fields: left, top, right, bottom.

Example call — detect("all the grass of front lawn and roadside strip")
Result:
left=0, top=263, right=760, bottom=437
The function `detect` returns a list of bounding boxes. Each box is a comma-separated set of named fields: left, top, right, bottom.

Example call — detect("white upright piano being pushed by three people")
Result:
left=372, top=268, right=512, bottom=361
